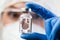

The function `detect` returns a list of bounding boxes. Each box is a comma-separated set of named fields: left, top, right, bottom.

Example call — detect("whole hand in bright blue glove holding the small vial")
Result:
left=21, top=2, right=60, bottom=40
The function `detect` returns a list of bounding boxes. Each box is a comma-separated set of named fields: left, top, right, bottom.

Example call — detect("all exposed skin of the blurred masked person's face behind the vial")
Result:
left=2, top=2, right=43, bottom=27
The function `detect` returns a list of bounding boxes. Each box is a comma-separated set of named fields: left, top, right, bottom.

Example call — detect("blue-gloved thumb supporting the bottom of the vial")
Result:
left=21, top=33, right=47, bottom=40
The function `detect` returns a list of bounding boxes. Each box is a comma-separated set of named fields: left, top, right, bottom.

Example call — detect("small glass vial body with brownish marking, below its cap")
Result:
left=20, top=14, right=32, bottom=33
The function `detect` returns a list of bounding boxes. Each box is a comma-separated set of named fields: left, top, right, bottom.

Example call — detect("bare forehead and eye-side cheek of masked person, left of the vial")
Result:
left=2, top=2, right=25, bottom=25
